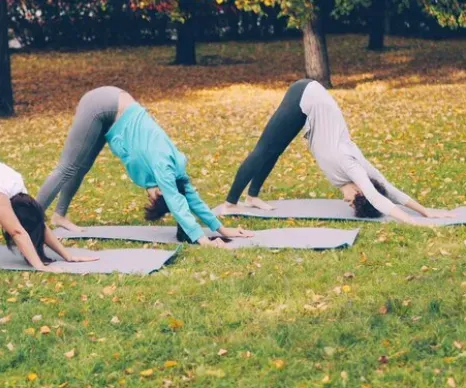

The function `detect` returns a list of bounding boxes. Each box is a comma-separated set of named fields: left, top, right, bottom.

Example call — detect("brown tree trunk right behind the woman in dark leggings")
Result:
left=303, top=12, right=332, bottom=88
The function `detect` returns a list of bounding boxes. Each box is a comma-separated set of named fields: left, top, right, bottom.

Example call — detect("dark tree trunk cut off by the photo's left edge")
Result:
left=0, top=0, right=15, bottom=117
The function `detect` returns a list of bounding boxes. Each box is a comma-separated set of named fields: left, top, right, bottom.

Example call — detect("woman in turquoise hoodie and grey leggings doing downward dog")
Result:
left=37, top=86, right=252, bottom=246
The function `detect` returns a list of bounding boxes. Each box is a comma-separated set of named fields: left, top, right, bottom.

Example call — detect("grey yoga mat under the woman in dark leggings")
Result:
left=213, top=199, right=466, bottom=225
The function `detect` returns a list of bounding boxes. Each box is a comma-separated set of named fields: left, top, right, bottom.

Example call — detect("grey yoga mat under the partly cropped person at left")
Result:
left=0, top=246, right=177, bottom=274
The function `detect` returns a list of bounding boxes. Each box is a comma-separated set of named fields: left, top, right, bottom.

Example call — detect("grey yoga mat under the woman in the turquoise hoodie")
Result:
left=54, top=226, right=359, bottom=249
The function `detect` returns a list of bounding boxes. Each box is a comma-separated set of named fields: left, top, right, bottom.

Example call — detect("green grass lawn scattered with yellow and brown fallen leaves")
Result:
left=0, top=36, right=466, bottom=387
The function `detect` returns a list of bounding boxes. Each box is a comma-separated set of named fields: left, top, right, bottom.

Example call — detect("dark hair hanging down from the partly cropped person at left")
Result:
left=2, top=193, right=55, bottom=264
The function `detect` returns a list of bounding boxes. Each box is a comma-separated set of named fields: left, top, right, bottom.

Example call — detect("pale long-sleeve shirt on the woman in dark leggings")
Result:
left=300, top=81, right=411, bottom=215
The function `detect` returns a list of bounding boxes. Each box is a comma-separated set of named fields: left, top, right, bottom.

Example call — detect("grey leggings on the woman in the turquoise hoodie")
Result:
left=37, top=86, right=122, bottom=216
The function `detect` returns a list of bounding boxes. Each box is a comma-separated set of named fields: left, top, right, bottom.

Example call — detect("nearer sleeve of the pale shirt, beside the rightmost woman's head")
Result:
left=343, top=157, right=396, bottom=215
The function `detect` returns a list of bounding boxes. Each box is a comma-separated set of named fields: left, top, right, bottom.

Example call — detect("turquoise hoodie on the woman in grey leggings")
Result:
left=105, top=103, right=222, bottom=241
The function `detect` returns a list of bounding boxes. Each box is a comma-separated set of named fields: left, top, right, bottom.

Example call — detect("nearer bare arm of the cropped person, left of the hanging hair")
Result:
left=0, top=193, right=51, bottom=271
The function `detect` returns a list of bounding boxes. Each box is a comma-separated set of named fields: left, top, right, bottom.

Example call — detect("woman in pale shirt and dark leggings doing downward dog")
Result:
left=223, top=79, right=452, bottom=224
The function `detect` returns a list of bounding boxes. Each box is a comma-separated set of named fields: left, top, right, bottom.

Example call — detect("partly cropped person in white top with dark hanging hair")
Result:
left=0, top=163, right=98, bottom=272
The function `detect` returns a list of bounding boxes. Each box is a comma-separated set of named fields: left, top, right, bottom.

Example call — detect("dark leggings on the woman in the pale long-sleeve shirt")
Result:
left=227, top=80, right=310, bottom=204
